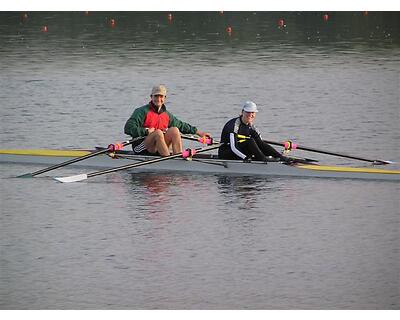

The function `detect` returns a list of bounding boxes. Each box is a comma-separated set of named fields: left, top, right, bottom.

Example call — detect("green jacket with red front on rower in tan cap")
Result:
left=124, top=102, right=197, bottom=138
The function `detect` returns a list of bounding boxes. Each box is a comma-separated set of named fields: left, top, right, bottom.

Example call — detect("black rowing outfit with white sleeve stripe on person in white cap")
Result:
left=218, top=116, right=283, bottom=161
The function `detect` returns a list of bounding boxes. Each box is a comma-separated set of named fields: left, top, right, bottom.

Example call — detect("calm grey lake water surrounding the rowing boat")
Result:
left=0, top=12, right=400, bottom=309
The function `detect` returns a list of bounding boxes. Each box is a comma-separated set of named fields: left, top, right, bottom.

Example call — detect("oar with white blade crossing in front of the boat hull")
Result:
left=54, top=143, right=222, bottom=182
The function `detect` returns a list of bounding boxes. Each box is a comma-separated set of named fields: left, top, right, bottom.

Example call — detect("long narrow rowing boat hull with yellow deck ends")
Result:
left=0, top=150, right=400, bottom=181
